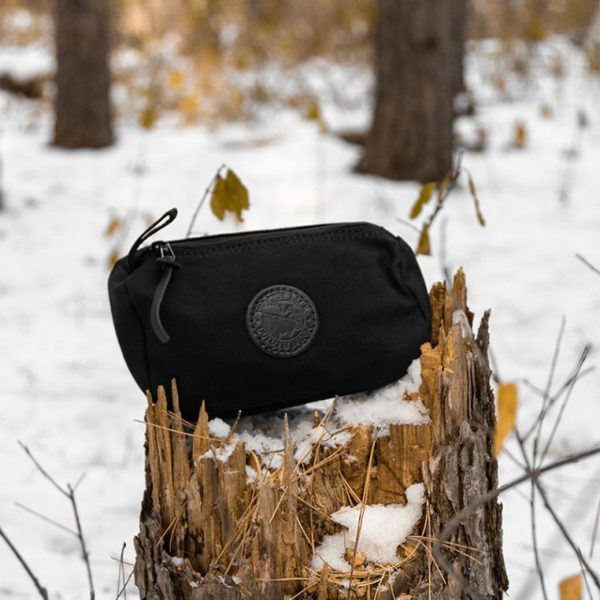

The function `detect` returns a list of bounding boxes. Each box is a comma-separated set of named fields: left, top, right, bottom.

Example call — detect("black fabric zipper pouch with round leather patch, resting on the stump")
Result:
left=108, top=209, right=431, bottom=421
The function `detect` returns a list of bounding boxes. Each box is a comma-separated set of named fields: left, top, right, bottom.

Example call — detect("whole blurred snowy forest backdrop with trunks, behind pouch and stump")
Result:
left=0, top=0, right=600, bottom=600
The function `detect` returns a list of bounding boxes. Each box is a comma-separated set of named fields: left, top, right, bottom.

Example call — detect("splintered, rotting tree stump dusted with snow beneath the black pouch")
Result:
left=135, top=271, right=508, bottom=600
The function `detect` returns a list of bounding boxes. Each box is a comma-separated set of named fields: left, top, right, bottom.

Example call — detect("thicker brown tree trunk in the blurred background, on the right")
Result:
left=358, top=0, right=466, bottom=181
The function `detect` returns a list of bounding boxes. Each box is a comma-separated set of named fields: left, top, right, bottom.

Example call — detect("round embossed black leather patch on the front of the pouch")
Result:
left=246, top=285, right=319, bottom=358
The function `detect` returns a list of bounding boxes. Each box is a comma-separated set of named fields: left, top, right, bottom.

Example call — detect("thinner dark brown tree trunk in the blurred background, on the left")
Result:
left=54, top=0, right=113, bottom=148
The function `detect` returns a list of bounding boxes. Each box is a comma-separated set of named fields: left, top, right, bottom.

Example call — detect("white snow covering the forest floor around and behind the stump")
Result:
left=0, top=35, right=600, bottom=600
